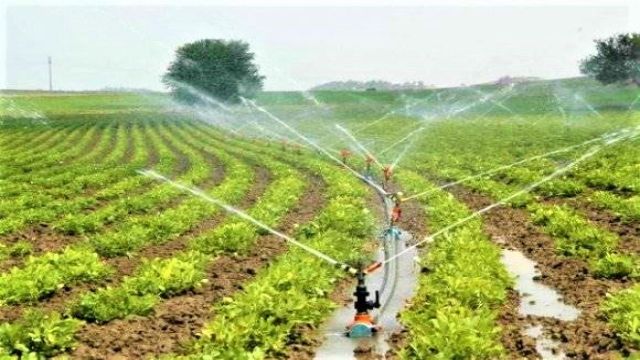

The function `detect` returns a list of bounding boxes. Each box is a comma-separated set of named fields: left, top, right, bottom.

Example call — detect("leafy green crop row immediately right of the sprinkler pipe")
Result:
left=397, top=171, right=513, bottom=359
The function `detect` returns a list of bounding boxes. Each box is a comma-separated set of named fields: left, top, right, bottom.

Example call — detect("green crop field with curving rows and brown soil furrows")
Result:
left=0, top=79, right=640, bottom=359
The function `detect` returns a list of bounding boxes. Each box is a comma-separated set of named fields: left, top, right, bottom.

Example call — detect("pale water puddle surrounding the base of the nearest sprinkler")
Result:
left=315, top=231, right=418, bottom=360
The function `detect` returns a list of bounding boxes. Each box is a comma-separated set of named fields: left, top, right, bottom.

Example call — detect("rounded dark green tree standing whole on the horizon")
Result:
left=162, top=39, right=264, bottom=104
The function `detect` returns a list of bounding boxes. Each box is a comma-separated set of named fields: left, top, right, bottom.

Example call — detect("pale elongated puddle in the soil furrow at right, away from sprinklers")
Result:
left=502, top=250, right=580, bottom=321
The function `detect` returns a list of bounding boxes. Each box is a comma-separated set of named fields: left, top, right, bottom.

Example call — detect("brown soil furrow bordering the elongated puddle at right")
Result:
left=451, top=187, right=629, bottom=359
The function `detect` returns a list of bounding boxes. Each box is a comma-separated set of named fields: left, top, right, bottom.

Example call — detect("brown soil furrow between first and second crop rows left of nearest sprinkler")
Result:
left=71, top=173, right=324, bottom=359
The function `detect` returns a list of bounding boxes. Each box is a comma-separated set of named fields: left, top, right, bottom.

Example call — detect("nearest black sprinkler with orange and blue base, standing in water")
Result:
left=347, top=270, right=380, bottom=338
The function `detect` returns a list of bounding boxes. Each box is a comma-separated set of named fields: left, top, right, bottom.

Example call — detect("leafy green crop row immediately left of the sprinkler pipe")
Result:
left=178, top=158, right=373, bottom=359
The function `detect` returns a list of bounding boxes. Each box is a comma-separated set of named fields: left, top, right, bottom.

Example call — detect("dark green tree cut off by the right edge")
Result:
left=580, top=33, right=640, bottom=85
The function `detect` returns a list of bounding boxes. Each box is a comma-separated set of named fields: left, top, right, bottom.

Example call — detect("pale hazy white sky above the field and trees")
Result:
left=0, top=0, right=640, bottom=90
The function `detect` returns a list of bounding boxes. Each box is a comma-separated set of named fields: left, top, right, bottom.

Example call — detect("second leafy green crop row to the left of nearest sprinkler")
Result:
left=71, top=146, right=305, bottom=323
